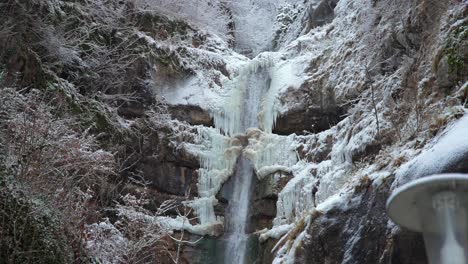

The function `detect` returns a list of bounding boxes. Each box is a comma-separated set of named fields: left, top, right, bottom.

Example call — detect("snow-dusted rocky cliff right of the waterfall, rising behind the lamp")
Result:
left=265, top=0, right=468, bottom=264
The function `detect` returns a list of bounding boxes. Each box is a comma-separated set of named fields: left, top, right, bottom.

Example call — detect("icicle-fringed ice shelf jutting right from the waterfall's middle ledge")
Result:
left=244, top=129, right=298, bottom=178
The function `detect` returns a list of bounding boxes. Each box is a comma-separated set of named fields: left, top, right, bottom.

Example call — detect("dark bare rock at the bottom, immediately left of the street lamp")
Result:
left=295, top=177, right=427, bottom=264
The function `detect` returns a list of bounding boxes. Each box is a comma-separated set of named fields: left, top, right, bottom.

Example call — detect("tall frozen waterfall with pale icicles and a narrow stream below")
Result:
left=186, top=52, right=297, bottom=264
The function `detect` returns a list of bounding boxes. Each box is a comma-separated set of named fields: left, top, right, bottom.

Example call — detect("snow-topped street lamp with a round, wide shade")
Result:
left=387, top=174, right=468, bottom=264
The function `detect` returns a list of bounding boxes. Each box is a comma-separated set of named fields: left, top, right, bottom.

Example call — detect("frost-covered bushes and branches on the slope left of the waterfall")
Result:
left=0, top=0, right=214, bottom=263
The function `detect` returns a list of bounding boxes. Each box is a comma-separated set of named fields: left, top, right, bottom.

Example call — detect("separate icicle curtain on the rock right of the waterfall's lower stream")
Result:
left=273, top=161, right=317, bottom=225
